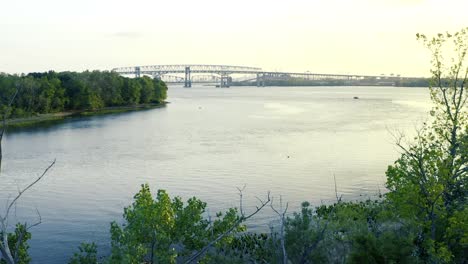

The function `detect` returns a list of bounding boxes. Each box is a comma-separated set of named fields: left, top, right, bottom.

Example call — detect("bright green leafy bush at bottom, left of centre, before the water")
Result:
left=109, top=185, right=247, bottom=263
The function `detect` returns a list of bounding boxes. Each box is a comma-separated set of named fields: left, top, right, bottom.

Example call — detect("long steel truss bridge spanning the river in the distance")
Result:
left=112, top=64, right=403, bottom=87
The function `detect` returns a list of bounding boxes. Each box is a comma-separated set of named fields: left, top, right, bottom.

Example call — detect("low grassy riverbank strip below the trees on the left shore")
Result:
left=0, top=102, right=168, bottom=128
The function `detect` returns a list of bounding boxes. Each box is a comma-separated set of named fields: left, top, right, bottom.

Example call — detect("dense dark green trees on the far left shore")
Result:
left=0, top=71, right=167, bottom=117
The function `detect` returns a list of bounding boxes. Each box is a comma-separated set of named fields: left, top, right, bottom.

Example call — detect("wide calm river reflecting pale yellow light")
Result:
left=0, top=86, right=430, bottom=263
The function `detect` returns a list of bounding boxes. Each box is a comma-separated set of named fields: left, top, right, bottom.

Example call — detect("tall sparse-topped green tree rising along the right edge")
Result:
left=387, top=28, right=468, bottom=263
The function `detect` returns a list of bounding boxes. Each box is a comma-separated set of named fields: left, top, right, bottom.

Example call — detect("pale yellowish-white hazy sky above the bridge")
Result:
left=0, top=0, right=468, bottom=76
